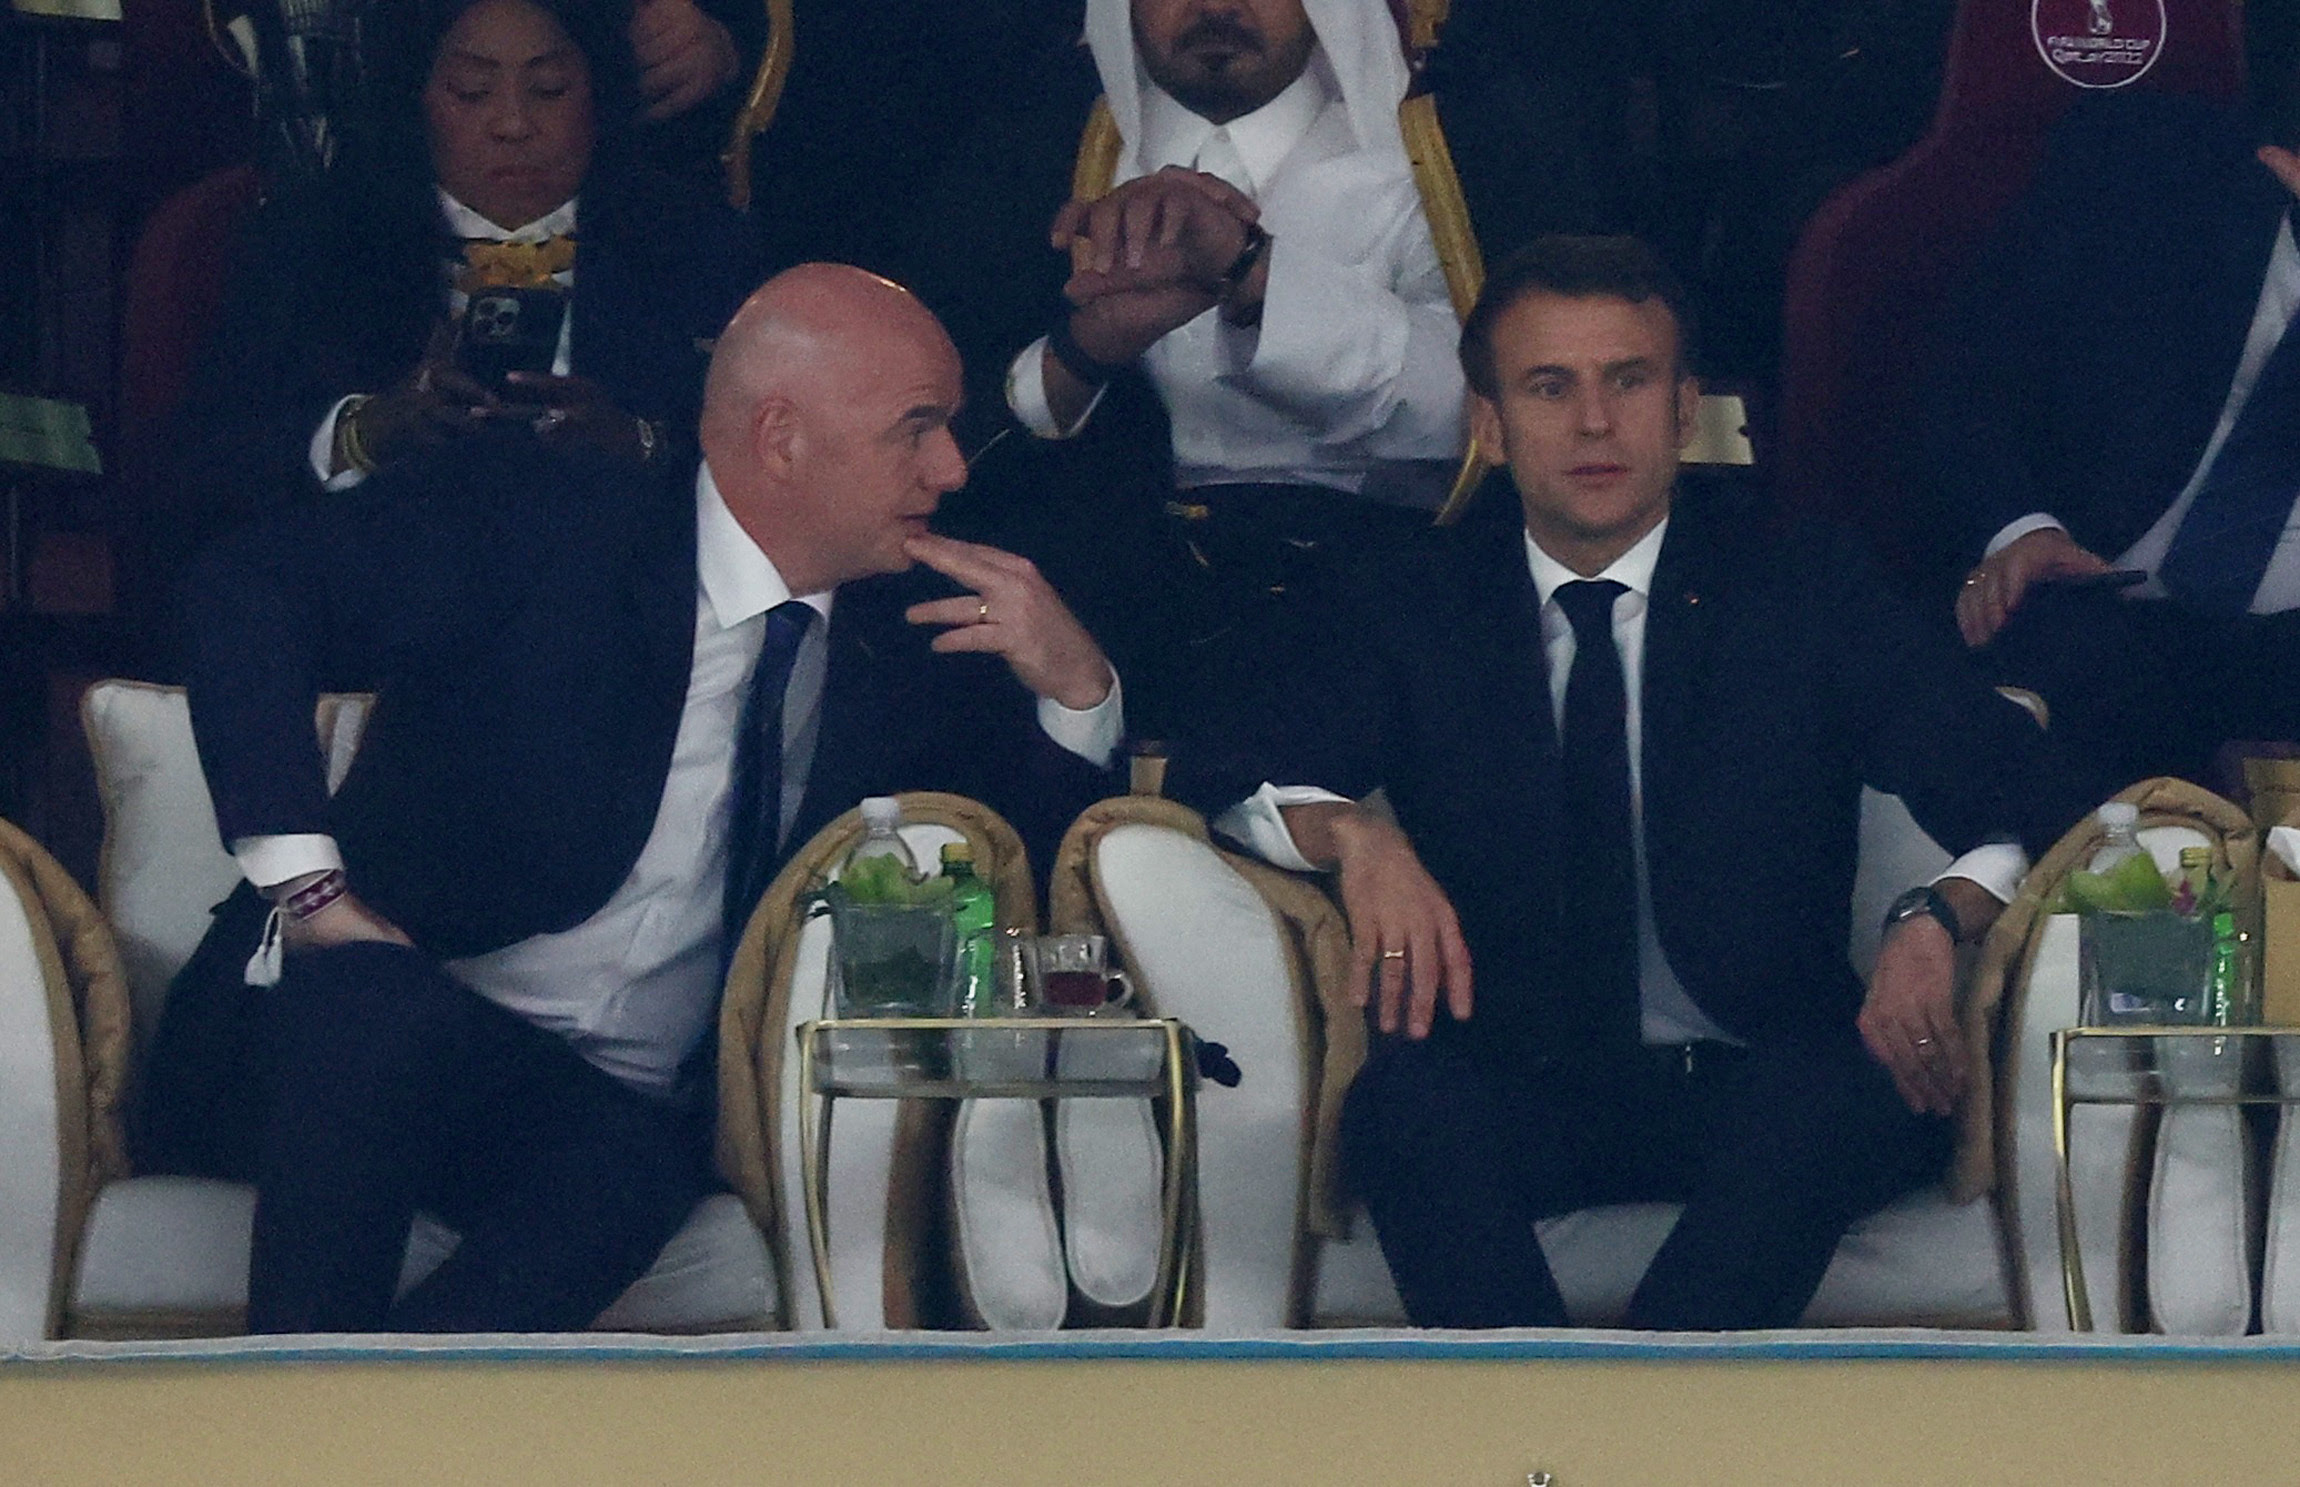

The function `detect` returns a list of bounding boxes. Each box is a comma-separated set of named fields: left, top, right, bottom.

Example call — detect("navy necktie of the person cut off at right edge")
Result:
left=2157, top=282, right=2300, bottom=616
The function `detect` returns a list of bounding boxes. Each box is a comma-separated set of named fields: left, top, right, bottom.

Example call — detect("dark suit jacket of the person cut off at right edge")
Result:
left=1923, top=92, right=2291, bottom=561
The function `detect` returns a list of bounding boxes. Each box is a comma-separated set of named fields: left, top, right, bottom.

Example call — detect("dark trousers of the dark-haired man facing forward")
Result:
left=1341, top=1030, right=1950, bottom=1331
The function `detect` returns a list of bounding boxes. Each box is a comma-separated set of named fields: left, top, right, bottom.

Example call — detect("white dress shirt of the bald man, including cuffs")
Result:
left=232, top=467, right=1125, bottom=1094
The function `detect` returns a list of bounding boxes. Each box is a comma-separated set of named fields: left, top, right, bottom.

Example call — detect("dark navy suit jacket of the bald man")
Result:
left=191, top=439, right=1109, bottom=956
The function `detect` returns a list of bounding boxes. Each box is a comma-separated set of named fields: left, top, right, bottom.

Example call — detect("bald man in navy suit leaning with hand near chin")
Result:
left=138, top=264, right=1122, bottom=1331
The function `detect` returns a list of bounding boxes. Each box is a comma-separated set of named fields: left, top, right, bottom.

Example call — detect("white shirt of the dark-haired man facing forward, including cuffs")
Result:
left=1214, top=519, right=2029, bottom=1043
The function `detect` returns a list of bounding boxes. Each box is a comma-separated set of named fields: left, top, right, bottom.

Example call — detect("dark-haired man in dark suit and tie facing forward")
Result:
left=1175, top=237, right=2077, bottom=1328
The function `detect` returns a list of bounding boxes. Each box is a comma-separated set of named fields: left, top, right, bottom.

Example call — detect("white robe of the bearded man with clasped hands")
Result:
left=1007, top=48, right=1465, bottom=506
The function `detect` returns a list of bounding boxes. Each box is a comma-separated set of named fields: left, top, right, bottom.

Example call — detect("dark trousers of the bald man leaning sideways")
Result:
left=161, top=945, right=715, bottom=1333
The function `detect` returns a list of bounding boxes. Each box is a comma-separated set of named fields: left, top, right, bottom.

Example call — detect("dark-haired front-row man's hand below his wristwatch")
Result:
left=1858, top=878, right=2003, bottom=1115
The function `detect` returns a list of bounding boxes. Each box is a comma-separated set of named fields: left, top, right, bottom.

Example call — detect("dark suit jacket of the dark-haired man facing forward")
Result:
left=1175, top=490, right=2082, bottom=1057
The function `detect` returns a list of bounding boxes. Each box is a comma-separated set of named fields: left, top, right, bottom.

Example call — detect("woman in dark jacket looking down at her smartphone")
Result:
left=173, top=0, right=761, bottom=597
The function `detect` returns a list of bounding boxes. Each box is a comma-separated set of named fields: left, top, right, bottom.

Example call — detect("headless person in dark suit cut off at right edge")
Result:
left=1923, top=74, right=2300, bottom=795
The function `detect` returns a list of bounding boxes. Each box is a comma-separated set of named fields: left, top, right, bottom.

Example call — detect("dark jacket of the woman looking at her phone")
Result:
left=167, top=161, right=761, bottom=611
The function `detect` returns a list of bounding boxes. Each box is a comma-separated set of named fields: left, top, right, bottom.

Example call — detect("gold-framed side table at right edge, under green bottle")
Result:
left=2052, top=1027, right=2300, bottom=1333
